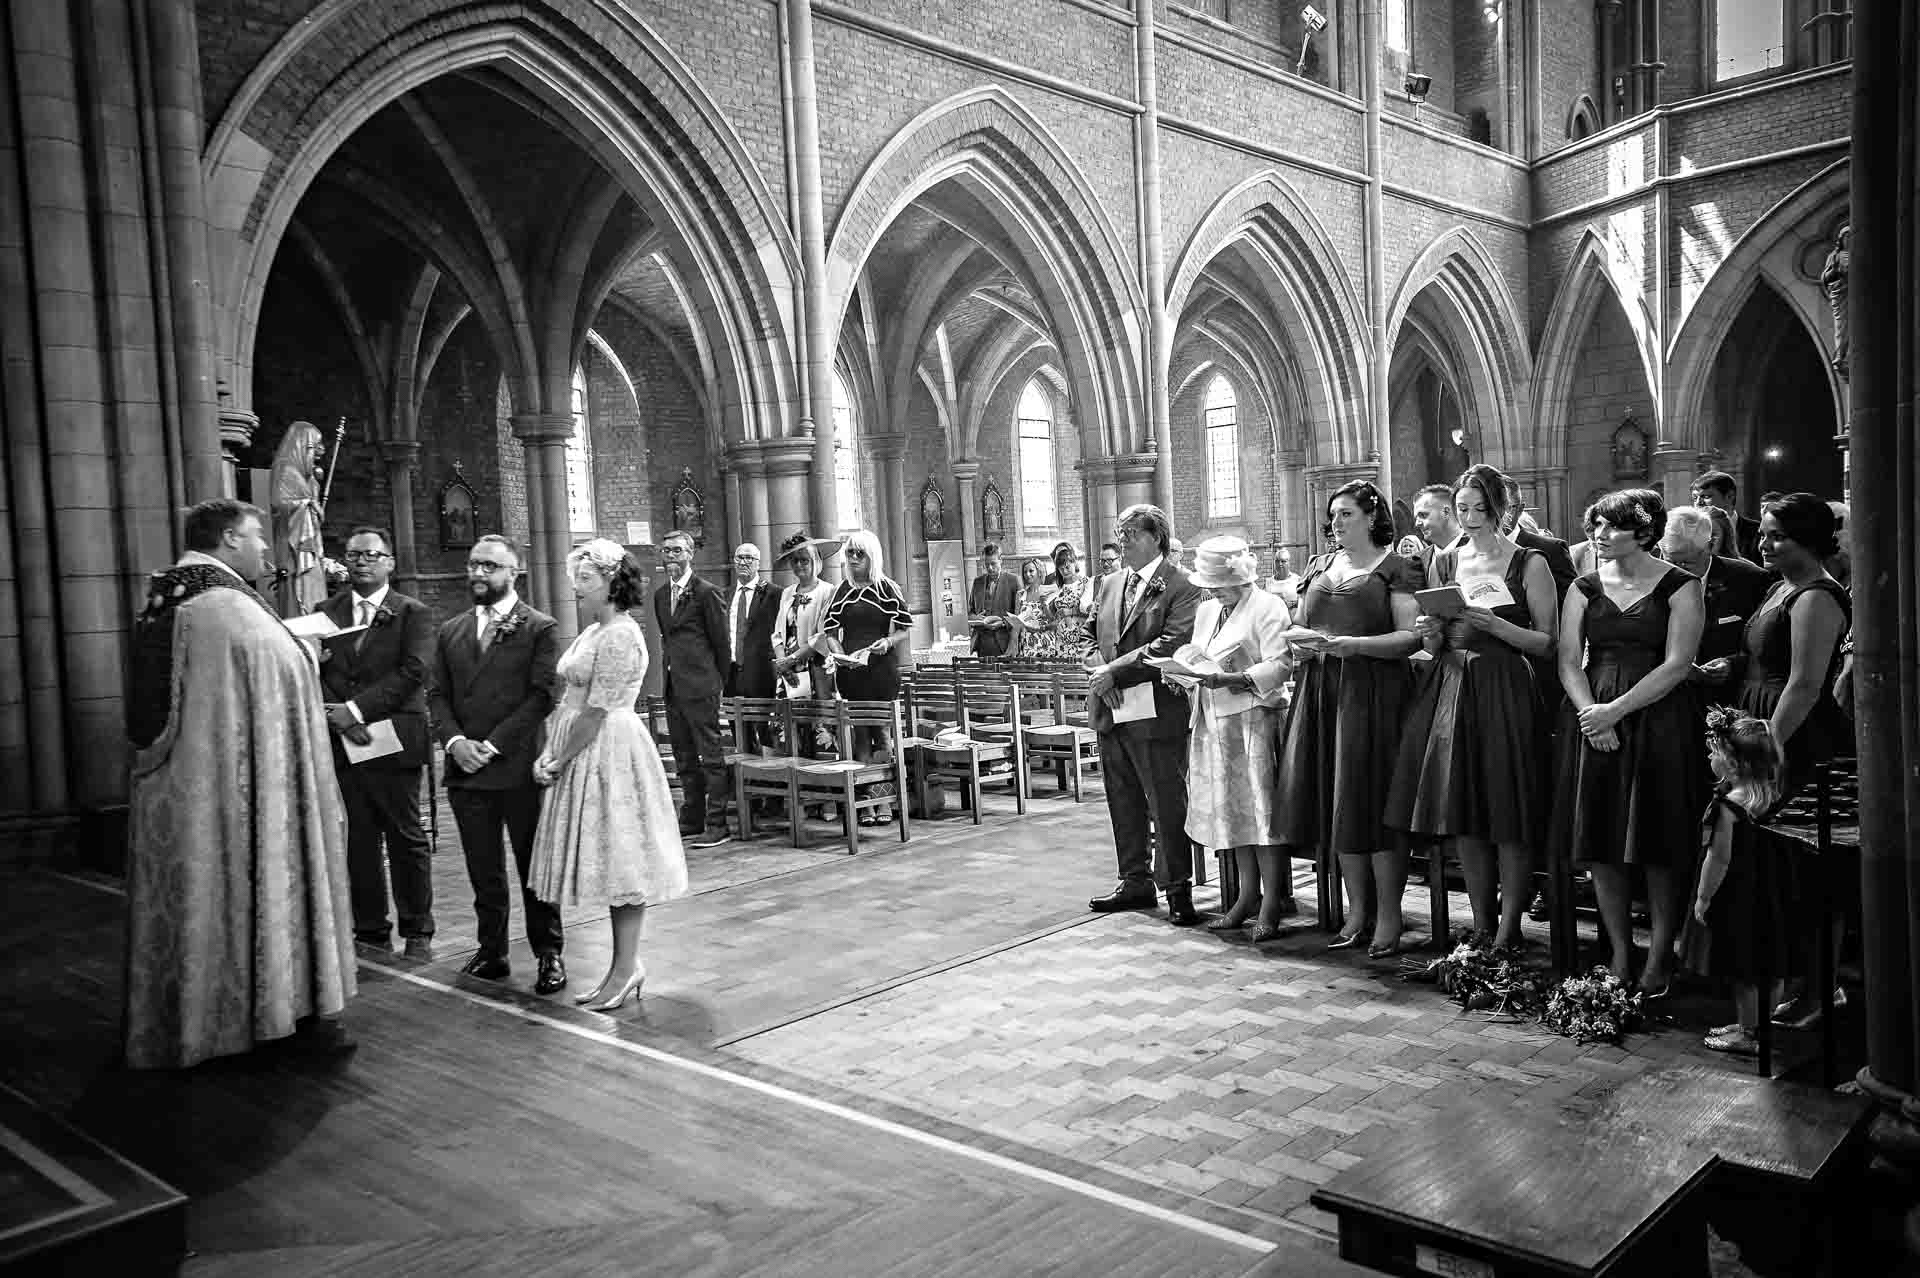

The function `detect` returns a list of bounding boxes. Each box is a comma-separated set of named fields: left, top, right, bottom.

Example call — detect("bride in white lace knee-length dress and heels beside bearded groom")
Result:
left=528, top=539, right=687, bottom=1011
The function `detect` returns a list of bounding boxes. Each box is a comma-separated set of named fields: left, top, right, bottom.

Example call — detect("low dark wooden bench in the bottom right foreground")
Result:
left=1311, top=1065, right=1872, bottom=1278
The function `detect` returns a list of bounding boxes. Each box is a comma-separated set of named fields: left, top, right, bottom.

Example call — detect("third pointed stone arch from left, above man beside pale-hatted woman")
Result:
left=1167, top=169, right=1373, bottom=464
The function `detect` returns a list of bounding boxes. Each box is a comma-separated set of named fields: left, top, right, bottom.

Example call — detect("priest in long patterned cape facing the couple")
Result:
left=121, top=501, right=355, bottom=1069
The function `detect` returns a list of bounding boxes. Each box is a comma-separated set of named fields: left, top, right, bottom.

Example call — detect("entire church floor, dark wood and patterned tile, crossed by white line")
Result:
left=0, top=771, right=1812, bottom=1276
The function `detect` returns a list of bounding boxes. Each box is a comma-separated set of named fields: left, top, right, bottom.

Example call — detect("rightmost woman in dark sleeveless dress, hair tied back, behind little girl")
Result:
left=1734, top=493, right=1853, bottom=794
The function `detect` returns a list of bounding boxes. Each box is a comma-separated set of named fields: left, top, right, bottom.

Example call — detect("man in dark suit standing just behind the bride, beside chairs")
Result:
left=653, top=530, right=725, bottom=848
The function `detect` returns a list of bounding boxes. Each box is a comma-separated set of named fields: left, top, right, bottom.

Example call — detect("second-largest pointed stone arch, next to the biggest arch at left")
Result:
left=828, top=86, right=1150, bottom=455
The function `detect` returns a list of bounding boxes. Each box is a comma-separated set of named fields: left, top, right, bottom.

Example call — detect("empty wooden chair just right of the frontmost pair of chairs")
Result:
left=906, top=679, right=1027, bottom=825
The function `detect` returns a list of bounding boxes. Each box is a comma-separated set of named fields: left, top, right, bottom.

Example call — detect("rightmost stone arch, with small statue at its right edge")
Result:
left=1665, top=159, right=1851, bottom=449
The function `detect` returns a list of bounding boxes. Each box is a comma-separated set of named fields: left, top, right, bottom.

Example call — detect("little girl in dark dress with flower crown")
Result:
left=1680, top=706, right=1793, bottom=1055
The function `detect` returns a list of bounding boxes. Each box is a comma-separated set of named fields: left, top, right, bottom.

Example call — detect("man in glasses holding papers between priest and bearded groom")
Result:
left=315, top=526, right=434, bottom=958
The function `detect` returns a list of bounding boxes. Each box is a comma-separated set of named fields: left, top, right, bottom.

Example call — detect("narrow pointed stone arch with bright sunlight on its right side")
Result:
left=1530, top=226, right=1665, bottom=466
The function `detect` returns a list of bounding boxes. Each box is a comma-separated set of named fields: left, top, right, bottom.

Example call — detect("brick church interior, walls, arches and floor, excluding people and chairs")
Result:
left=0, top=0, right=1920, bottom=1278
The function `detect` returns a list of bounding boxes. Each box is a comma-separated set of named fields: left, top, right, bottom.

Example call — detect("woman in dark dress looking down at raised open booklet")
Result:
left=1386, top=464, right=1555, bottom=948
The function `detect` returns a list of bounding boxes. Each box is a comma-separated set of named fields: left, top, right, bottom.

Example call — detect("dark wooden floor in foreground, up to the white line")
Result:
left=0, top=859, right=1352, bottom=1278
